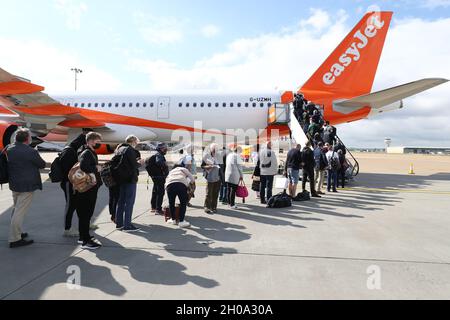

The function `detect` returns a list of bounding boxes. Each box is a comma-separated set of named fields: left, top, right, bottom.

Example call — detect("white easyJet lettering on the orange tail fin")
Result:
left=323, top=14, right=385, bottom=85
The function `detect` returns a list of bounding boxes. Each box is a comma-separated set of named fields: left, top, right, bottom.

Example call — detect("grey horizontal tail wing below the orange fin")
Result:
left=334, top=78, right=448, bottom=111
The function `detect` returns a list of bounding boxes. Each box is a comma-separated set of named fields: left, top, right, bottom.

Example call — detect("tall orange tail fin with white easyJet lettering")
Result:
left=300, top=12, right=393, bottom=100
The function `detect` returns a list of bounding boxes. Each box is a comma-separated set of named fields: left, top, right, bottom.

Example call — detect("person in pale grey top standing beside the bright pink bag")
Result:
left=225, top=146, right=244, bottom=209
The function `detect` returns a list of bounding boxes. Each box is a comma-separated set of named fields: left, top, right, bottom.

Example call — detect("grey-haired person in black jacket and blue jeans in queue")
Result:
left=113, top=135, right=143, bottom=232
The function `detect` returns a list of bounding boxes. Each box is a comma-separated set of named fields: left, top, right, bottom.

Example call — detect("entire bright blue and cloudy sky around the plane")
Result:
left=0, top=0, right=450, bottom=147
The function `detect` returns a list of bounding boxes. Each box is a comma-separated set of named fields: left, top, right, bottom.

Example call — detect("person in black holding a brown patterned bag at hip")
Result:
left=74, top=132, right=102, bottom=250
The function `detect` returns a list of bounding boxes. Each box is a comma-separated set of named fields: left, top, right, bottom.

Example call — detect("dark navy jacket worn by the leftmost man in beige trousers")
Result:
left=6, top=143, right=46, bottom=192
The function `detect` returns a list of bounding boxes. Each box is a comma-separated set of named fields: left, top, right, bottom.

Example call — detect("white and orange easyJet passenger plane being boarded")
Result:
left=0, top=12, right=448, bottom=153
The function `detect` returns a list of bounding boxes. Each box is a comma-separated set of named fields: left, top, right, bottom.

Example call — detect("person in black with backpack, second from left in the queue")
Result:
left=59, top=132, right=86, bottom=238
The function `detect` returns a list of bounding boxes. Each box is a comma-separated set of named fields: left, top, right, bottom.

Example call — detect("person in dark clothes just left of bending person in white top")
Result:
left=145, top=143, right=169, bottom=215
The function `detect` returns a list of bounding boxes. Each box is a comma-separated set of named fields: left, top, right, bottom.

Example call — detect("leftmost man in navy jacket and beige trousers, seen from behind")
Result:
left=4, top=129, right=46, bottom=248
